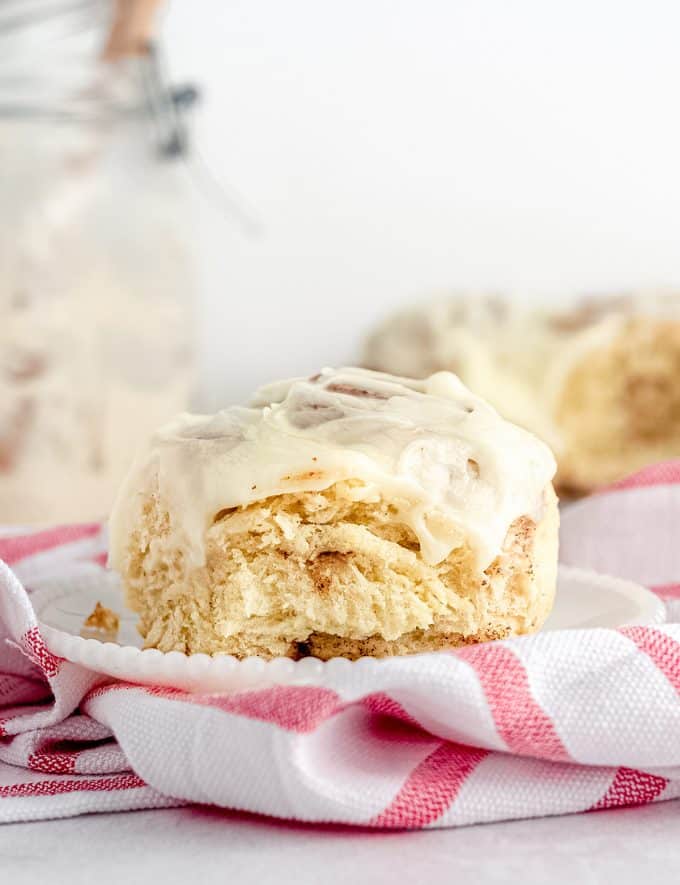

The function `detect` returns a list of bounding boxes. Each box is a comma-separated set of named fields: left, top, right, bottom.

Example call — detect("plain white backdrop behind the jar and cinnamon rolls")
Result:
left=163, top=0, right=680, bottom=408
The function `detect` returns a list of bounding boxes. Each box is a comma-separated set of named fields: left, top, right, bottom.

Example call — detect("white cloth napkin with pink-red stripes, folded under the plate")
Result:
left=0, top=461, right=680, bottom=828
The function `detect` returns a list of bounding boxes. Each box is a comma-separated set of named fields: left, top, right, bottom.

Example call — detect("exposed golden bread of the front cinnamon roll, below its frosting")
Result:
left=118, top=482, right=557, bottom=658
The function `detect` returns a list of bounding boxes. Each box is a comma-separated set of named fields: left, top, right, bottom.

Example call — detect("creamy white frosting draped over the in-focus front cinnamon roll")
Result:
left=110, top=368, right=555, bottom=571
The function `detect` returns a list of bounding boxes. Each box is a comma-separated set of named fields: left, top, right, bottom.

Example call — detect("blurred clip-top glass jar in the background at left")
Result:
left=0, top=0, right=194, bottom=524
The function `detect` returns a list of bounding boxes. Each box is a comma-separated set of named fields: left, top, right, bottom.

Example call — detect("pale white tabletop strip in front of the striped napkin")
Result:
left=0, top=800, right=680, bottom=885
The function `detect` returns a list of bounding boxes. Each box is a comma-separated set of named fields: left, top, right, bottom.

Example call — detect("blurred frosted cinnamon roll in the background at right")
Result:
left=363, top=294, right=680, bottom=495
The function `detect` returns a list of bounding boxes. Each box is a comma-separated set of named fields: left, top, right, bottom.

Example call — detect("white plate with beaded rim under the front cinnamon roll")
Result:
left=31, top=565, right=665, bottom=692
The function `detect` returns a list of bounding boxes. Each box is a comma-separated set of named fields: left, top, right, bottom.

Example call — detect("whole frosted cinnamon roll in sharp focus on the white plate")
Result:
left=111, top=368, right=557, bottom=659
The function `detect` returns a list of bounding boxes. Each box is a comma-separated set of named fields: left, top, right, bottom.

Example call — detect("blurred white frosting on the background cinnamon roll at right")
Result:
left=364, top=292, right=680, bottom=458
